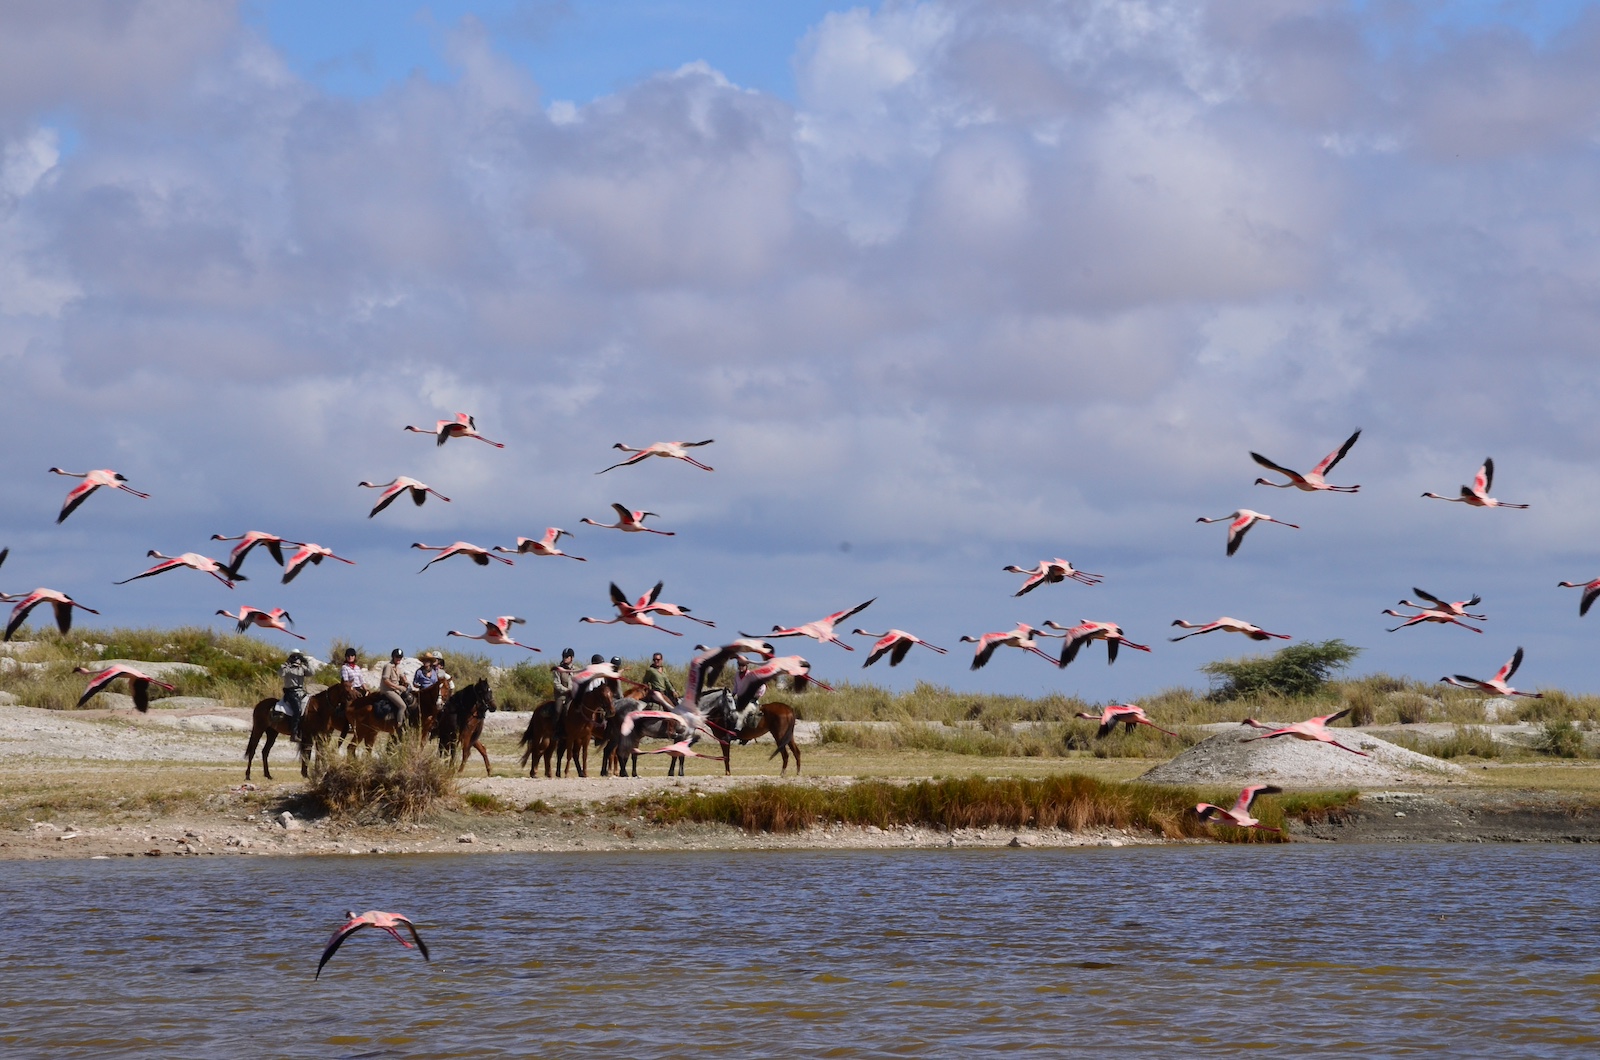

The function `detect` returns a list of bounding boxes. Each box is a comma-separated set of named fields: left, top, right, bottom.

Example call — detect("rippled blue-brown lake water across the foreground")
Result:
left=0, top=845, right=1600, bottom=1060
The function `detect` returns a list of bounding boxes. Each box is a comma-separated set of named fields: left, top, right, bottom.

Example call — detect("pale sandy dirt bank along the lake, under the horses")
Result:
left=0, top=701, right=1600, bottom=860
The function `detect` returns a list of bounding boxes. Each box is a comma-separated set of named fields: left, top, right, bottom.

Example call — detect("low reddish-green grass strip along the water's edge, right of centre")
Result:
left=627, top=773, right=1357, bottom=842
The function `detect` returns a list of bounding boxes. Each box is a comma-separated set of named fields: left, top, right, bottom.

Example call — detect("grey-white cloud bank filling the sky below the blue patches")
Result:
left=0, top=0, right=1600, bottom=697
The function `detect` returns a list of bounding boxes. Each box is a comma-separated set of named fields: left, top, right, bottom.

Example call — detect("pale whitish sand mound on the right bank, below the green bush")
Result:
left=1139, top=725, right=1466, bottom=788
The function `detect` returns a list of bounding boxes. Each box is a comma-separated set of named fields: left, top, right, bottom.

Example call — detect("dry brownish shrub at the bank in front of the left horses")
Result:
left=310, top=740, right=456, bottom=820
